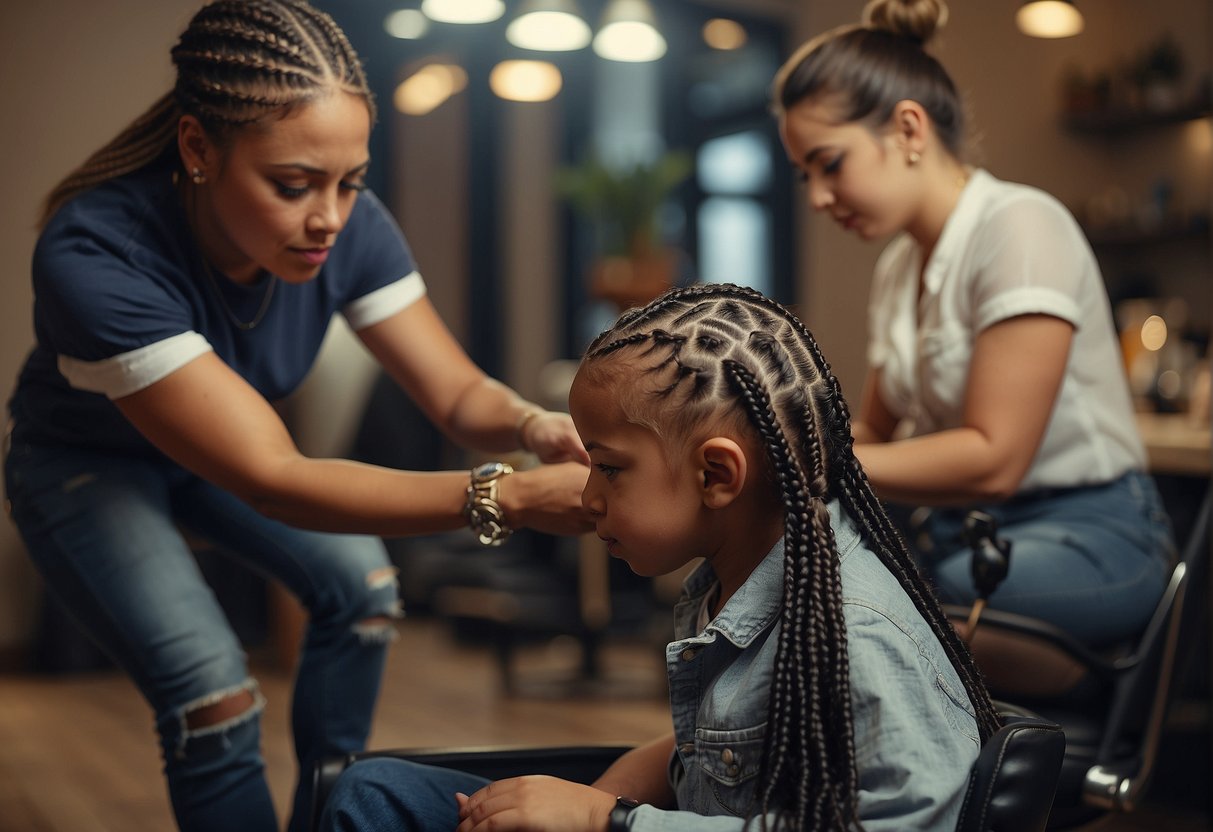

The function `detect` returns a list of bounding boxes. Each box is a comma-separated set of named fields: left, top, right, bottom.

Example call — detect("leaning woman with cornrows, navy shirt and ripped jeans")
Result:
left=5, top=0, right=591, bottom=832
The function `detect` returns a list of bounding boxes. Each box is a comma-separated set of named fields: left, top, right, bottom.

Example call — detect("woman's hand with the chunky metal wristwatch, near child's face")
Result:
left=499, top=462, right=594, bottom=535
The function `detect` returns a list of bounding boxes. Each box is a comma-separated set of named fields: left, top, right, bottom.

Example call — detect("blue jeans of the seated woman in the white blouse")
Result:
left=923, top=472, right=1175, bottom=646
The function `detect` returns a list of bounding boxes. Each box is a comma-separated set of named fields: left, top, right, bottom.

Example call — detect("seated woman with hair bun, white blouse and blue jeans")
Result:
left=774, top=0, right=1174, bottom=646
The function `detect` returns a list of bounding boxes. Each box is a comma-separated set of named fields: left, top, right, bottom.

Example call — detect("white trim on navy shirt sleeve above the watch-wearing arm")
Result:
left=58, top=331, right=213, bottom=399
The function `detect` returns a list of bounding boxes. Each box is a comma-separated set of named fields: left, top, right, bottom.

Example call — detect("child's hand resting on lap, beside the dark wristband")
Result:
left=455, top=775, right=615, bottom=832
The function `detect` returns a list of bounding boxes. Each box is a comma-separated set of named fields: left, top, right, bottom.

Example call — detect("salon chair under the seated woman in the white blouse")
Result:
left=945, top=486, right=1211, bottom=830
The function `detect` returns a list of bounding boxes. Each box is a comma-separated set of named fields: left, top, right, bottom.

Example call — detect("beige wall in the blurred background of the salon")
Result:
left=0, top=0, right=1211, bottom=651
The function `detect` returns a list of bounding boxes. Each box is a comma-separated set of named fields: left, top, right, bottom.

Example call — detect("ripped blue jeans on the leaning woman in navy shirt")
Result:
left=5, top=426, right=399, bottom=832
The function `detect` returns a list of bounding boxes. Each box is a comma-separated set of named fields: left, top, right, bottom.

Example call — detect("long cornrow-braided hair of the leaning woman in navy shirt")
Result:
left=39, top=0, right=375, bottom=228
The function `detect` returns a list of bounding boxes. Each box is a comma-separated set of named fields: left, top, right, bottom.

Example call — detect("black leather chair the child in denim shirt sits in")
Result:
left=312, top=710, right=1065, bottom=832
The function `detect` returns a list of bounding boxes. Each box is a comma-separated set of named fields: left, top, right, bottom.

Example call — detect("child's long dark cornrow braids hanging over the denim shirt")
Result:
left=582, top=284, right=998, bottom=830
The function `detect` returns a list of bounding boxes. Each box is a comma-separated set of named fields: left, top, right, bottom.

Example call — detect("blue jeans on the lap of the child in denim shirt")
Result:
left=320, top=757, right=489, bottom=832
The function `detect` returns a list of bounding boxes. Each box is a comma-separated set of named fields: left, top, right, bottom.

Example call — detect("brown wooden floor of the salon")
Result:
left=0, top=619, right=1213, bottom=832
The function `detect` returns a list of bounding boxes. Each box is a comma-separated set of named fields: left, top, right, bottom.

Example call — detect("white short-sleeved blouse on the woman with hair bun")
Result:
left=867, top=170, right=1145, bottom=491
